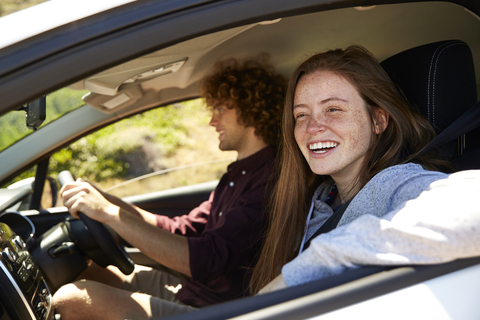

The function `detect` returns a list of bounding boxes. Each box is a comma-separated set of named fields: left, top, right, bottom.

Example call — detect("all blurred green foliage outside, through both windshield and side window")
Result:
left=0, top=84, right=208, bottom=185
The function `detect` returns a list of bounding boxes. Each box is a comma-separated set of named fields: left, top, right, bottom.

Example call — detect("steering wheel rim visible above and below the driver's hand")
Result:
left=58, top=171, right=135, bottom=275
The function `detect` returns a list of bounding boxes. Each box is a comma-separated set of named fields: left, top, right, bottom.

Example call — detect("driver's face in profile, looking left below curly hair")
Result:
left=210, top=105, right=249, bottom=153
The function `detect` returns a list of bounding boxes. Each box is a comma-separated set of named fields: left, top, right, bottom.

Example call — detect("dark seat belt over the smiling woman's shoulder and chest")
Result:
left=303, top=101, right=480, bottom=250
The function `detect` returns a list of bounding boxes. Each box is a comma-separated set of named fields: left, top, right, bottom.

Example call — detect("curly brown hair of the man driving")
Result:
left=201, top=55, right=287, bottom=146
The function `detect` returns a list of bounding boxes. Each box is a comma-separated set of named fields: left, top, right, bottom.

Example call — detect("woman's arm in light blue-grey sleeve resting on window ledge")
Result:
left=282, top=171, right=480, bottom=286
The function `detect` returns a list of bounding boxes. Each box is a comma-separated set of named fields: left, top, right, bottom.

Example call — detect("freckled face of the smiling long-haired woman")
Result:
left=293, top=71, right=374, bottom=183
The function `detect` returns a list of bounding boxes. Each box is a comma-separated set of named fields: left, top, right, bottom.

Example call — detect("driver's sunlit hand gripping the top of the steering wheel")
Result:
left=60, top=179, right=119, bottom=224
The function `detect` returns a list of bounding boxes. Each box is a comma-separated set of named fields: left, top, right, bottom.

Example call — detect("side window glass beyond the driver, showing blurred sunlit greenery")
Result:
left=49, top=99, right=236, bottom=197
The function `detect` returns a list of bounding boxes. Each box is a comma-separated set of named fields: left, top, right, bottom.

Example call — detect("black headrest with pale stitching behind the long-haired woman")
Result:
left=381, top=40, right=477, bottom=134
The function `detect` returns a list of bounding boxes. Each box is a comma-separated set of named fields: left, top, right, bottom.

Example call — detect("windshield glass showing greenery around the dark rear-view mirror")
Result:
left=0, top=88, right=88, bottom=151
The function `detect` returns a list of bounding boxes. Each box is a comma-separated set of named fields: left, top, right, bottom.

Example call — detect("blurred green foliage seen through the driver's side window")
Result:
left=49, top=100, right=206, bottom=182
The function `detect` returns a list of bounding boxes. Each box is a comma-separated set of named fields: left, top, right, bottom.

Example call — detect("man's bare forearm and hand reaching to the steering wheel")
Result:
left=60, top=182, right=191, bottom=276
